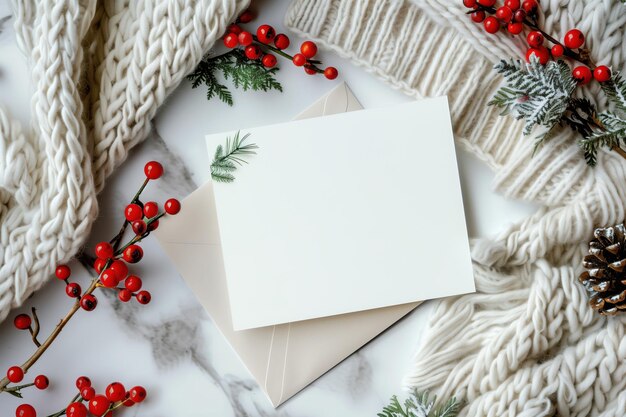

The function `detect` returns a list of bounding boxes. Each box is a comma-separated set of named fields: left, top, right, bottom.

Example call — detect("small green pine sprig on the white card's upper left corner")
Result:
left=211, top=132, right=259, bottom=182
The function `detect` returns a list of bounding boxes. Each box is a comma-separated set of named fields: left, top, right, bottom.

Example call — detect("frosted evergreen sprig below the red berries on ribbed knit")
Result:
left=489, top=56, right=626, bottom=166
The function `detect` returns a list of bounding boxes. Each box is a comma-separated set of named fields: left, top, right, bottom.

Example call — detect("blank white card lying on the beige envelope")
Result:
left=207, top=97, right=474, bottom=330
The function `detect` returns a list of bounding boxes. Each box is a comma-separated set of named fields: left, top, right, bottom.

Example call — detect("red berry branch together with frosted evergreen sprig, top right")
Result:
left=463, top=0, right=626, bottom=166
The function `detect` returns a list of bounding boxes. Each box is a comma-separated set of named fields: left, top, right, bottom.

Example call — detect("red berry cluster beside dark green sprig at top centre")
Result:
left=222, top=10, right=339, bottom=80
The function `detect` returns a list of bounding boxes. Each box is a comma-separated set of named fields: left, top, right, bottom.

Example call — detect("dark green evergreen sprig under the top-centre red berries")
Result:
left=187, top=48, right=283, bottom=106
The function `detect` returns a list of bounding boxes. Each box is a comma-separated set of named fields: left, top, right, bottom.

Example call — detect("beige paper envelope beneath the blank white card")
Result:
left=154, top=83, right=419, bottom=407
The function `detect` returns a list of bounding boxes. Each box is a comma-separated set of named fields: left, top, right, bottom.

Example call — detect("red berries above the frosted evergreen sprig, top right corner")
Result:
left=463, top=0, right=611, bottom=85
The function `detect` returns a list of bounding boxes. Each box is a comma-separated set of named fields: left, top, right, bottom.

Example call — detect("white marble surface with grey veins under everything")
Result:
left=0, top=0, right=535, bottom=417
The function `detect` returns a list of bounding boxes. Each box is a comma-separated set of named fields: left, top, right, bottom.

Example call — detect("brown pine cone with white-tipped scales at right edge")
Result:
left=578, top=224, right=626, bottom=316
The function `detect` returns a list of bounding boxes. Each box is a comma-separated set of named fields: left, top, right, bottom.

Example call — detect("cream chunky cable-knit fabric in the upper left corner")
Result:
left=0, top=0, right=248, bottom=321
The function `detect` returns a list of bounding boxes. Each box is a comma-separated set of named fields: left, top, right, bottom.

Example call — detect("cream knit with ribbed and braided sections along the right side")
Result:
left=286, top=0, right=626, bottom=417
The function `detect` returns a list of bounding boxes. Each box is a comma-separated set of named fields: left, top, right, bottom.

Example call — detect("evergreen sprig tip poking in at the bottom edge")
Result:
left=378, top=390, right=461, bottom=417
